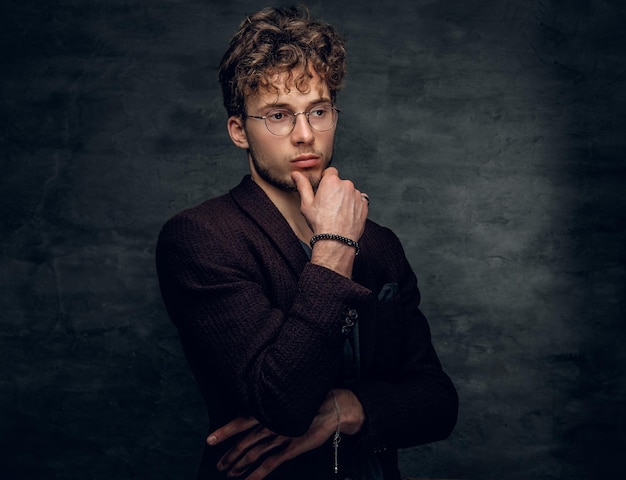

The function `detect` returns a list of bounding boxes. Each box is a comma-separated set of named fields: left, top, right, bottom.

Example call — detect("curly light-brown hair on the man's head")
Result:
left=218, top=7, right=346, bottom=116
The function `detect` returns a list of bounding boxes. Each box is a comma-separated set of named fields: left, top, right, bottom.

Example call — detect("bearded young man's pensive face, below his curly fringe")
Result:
left=230, top=72, right=335, bottom=191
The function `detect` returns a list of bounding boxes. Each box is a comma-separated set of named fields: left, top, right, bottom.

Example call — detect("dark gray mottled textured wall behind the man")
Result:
left=0, top=0, right=626, bottom=480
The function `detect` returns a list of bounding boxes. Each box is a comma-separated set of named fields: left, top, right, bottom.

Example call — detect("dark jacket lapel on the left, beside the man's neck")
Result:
left=230, top=175, right=308, bottom=275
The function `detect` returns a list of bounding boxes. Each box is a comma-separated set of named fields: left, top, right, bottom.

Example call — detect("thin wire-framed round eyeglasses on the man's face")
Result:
left=245, top=104, right=340, bottom=137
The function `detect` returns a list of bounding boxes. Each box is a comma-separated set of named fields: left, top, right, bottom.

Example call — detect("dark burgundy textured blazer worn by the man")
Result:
left=156, top=176, right=458, bottom=480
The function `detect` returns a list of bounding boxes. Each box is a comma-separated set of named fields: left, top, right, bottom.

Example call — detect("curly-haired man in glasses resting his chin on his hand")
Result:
left=157, top=4, right=457, bottom=480
